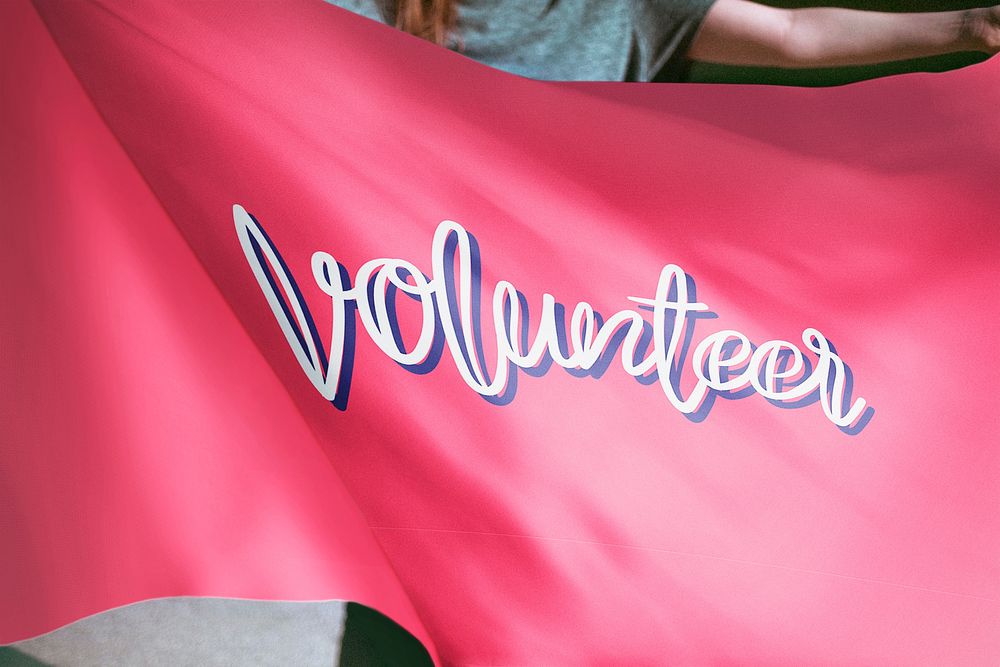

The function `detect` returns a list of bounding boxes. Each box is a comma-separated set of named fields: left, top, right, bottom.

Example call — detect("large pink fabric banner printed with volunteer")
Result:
left=0, top=1, right=1000, bottom=665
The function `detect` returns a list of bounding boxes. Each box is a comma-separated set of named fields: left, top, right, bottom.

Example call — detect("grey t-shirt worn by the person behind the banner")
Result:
left=327, top=0, right=714, bottom=81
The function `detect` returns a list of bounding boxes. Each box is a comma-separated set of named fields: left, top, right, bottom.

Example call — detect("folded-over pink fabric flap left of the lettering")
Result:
left=0, top=3, right=434, bottom=656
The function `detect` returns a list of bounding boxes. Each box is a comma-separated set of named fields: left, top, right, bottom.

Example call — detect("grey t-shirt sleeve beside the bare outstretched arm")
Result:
left=631, top=0, right=715, bottom=81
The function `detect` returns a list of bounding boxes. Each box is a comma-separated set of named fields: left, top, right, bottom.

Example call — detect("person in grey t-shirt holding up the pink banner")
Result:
left=330, top=0, right=1000, bottom=81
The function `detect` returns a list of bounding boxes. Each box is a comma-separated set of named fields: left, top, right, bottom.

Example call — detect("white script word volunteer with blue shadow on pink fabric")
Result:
left=233, top=205, right=871, bottom=429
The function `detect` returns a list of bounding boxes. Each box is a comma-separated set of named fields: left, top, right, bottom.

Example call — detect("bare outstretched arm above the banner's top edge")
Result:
left=689, top=0, right=1000, bottom=67
